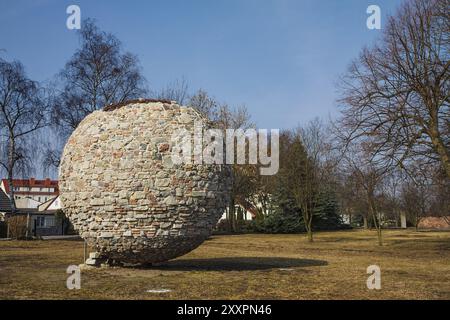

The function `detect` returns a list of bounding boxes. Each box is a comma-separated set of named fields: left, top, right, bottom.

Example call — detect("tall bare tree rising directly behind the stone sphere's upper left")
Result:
left=46, top=19, right=147, bottom=170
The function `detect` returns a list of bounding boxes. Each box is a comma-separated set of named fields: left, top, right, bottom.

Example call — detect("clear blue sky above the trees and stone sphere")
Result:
left=0, top=0, right=401, bottom=128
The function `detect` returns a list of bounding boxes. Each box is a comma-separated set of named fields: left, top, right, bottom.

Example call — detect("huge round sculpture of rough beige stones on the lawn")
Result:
left=59, top=99, right=231, bottom=264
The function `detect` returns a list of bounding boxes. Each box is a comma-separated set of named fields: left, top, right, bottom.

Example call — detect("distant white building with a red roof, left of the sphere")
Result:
left=0, top=178, right=59, bottom=203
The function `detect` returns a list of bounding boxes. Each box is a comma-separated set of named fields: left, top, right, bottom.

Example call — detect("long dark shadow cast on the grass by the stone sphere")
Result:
left=147, top=257, right=328, bottom=271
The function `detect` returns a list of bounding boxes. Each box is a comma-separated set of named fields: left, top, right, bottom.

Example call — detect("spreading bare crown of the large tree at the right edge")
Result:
left=340, top=0, right=450, bottom=177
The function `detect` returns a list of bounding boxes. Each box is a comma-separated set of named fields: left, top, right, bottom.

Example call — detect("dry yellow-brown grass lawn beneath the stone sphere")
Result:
left=0, top=230, right=450, bottom=299
